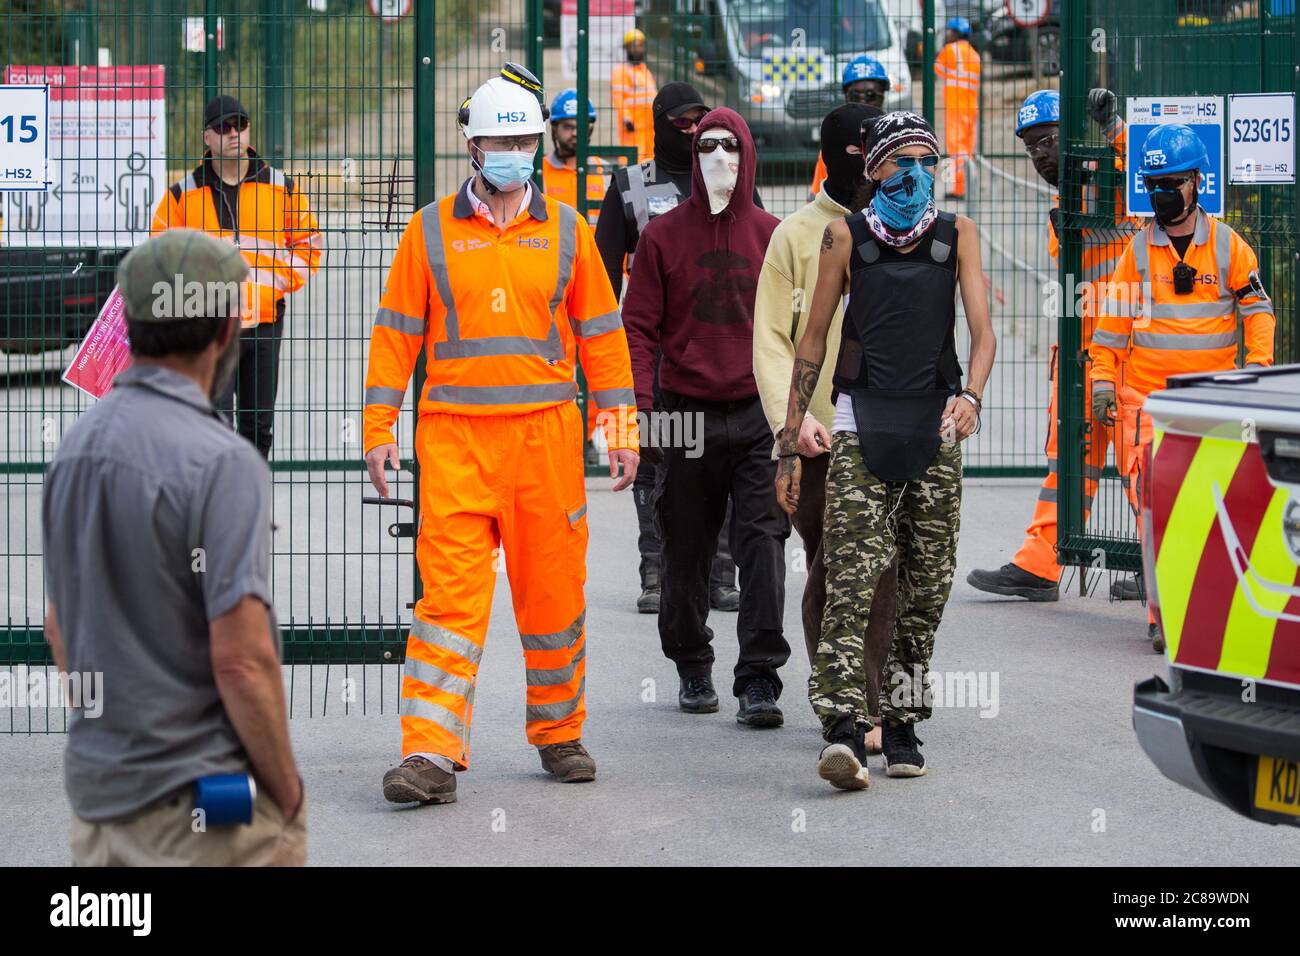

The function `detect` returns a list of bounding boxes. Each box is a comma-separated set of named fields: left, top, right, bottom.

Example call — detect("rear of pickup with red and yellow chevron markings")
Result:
left=1134, top=365, right=1300, bottom=825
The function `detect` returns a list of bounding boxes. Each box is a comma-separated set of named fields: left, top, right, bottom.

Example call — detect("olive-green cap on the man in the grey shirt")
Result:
left=117, top=229, right=248, bottom=323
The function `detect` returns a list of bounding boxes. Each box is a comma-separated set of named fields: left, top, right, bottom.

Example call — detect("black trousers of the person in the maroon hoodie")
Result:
left=654, top=389, right=790, bottom=696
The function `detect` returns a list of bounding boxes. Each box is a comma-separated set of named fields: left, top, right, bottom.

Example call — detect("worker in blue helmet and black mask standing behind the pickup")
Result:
left=1088, top=124, right=1277, bottom=650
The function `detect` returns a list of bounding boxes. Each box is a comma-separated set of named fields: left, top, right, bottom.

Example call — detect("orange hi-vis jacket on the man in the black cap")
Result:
left=150, top=150, right=325, bottom=326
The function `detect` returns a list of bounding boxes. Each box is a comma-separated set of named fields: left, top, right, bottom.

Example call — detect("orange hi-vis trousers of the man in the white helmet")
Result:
left=400, top=402, right=588, bottom=767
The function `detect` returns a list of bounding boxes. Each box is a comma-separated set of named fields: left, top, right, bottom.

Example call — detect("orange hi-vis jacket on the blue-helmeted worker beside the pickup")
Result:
left=1088, top=209, right=1277, bottom=395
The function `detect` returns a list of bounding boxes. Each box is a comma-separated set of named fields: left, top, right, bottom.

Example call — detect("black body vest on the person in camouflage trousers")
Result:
left=833, top=212, right=962, bottom=481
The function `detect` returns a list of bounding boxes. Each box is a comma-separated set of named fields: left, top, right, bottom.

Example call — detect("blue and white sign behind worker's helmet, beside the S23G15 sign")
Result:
left=1125, top=96, right=1227, bottom=216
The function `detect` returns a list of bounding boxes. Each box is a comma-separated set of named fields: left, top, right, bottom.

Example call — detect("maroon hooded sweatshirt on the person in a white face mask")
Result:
left=623, top=107, right=777, bottom=410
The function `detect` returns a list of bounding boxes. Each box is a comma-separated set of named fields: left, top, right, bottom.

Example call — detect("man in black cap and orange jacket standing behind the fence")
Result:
left=151, top=95, right=325, bottom=458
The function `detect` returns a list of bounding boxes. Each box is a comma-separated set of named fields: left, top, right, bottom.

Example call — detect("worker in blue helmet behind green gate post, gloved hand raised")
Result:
left=966, top=88, right=1141, bottom=601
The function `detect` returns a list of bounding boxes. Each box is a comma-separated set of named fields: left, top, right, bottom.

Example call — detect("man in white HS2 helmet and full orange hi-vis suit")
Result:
left=365, top=64, right=640, bottom=803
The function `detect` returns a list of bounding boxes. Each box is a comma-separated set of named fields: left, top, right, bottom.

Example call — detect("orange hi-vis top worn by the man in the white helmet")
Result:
left=364, top=185, right=641, bottom=453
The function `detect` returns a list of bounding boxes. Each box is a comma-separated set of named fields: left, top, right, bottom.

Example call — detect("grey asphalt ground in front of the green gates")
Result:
left=0, top=480, right=1296, bottom=866
